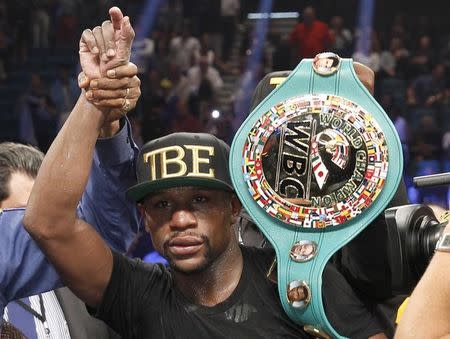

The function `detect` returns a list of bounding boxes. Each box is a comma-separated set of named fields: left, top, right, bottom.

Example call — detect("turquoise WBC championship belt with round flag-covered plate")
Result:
left=230, top=53, right=403, bottom=338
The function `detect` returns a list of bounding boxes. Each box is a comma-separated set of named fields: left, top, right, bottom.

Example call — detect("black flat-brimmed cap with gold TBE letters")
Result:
left=127, top=133, right=234, bottom=202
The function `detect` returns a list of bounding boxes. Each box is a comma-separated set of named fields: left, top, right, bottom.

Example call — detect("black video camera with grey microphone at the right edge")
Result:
left=384, top=173, right=450, bottom=294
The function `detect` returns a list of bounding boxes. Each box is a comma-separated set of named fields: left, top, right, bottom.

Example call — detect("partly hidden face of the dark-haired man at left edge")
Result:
left=0, top=172, right=34, bottom=208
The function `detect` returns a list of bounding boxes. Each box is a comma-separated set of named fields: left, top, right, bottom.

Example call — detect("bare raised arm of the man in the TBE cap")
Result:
left=24, top=5, right=136, bottom=306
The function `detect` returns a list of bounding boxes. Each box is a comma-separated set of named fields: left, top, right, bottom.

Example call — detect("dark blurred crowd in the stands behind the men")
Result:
left=0, top=0, right=450, bottom=206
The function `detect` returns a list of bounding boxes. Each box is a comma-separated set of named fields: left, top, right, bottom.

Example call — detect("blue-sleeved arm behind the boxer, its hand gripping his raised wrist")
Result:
left=0, top=68, right=140, bottom=322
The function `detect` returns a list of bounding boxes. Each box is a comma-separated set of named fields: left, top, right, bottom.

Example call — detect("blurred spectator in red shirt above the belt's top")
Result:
left=290, top=6, right=333, bottom=60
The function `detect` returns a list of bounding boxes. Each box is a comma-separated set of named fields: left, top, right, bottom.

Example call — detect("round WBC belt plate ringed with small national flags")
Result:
left=242, top=94, right=388, bottom=228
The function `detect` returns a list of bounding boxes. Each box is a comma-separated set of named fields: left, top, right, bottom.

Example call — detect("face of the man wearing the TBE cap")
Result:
left=140, top=187, right=240, bottom=274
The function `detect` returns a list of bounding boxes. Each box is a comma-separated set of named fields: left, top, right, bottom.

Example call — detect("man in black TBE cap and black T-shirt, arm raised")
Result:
left=24, top=129, right=385, bottom=338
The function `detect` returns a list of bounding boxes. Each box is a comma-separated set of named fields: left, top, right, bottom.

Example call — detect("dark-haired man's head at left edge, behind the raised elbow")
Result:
left=0, top=142, right=44, bottom=208
